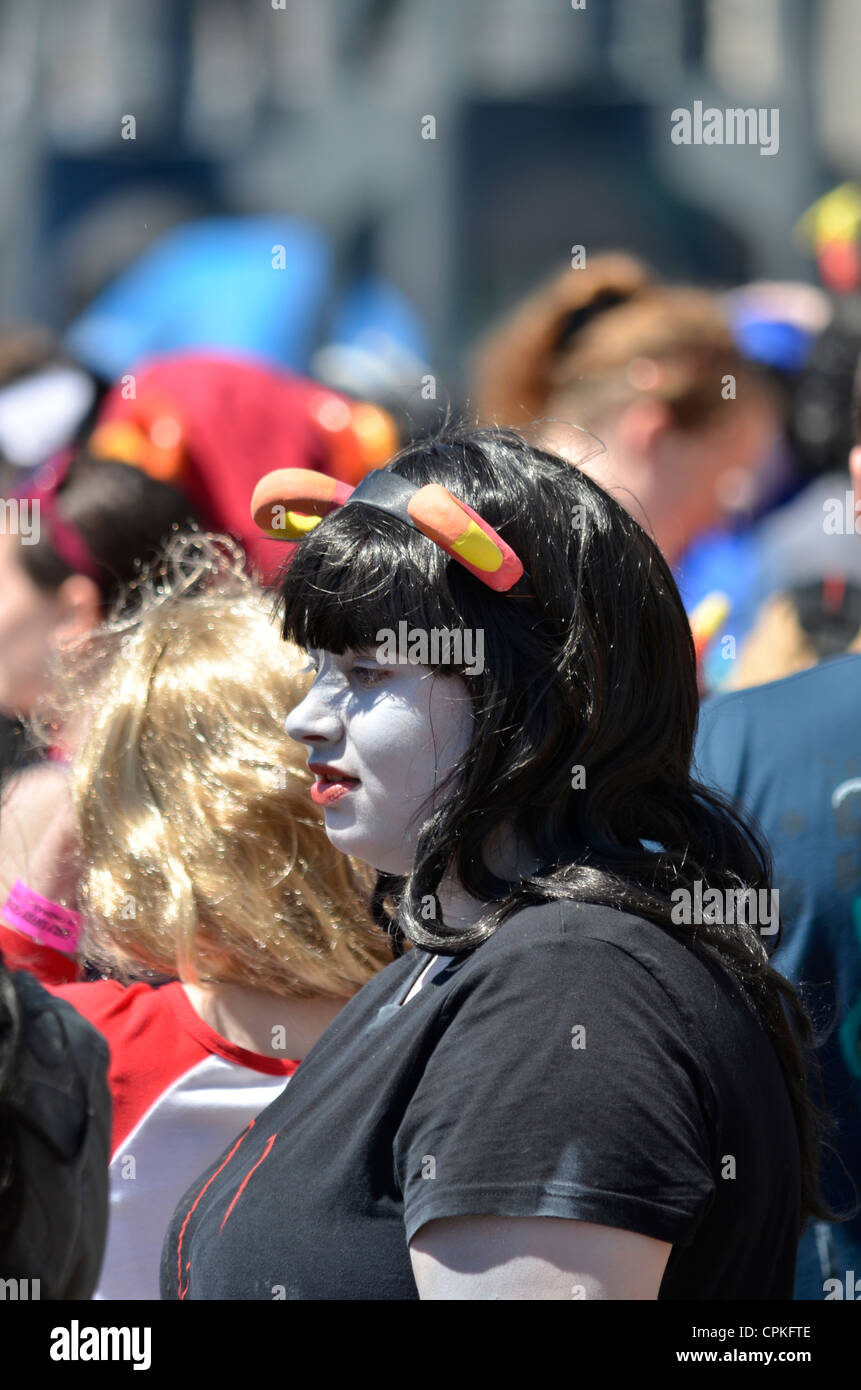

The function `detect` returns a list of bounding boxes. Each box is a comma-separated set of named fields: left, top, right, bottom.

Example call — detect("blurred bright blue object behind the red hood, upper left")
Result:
left=65, top=217, right=427, bottom=381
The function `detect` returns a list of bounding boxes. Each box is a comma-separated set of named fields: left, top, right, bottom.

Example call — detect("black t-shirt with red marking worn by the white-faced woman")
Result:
left=161, top=902, right=800, bottom=1300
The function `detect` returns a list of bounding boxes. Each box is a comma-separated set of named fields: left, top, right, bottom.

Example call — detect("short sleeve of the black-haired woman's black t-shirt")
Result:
left=395, top=933, right=716, bottom=1245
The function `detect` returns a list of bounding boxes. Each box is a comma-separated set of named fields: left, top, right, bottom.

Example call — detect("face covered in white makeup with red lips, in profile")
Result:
left=287, top=651, right=473, bottom=874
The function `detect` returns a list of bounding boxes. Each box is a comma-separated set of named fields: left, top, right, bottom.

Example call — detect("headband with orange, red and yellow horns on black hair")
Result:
left=252, top=468, right=524, bottom=592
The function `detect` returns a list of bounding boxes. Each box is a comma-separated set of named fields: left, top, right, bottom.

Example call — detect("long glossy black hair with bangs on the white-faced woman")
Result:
left=281, top=430, right=830, bottom=1218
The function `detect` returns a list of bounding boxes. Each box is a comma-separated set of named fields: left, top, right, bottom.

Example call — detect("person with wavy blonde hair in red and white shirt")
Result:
left=0, top=537, right=391, bottom=1298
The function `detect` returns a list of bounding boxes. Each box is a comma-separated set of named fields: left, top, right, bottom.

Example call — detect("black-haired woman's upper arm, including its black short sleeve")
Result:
left=394, top=922, right=715, bottom=1300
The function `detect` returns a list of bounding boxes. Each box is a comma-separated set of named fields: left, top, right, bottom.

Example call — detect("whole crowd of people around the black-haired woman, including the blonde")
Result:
left=0, top=202, right=861, bottom=1298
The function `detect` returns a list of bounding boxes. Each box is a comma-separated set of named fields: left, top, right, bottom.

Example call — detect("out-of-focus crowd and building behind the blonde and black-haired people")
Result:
left=0, top=0, right=861, bottom=1298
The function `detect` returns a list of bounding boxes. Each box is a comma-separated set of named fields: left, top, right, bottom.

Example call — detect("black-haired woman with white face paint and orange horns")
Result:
left=161, top=431, right=823, bottom=1300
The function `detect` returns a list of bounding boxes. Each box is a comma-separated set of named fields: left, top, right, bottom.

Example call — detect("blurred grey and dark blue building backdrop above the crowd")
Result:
left=0, top=0, right=861, bottom=373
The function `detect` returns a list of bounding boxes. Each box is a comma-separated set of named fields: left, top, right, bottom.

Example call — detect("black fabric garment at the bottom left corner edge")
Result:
left=0, top=970, right=111, bottom=1300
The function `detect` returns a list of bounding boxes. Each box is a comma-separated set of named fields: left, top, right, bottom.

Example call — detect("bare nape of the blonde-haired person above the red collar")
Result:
left=182, top=983, right=348, bottom=1062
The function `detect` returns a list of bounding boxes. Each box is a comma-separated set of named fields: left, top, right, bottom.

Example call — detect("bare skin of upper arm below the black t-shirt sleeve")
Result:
left=409, top=1216, right=672, bottom=1301
